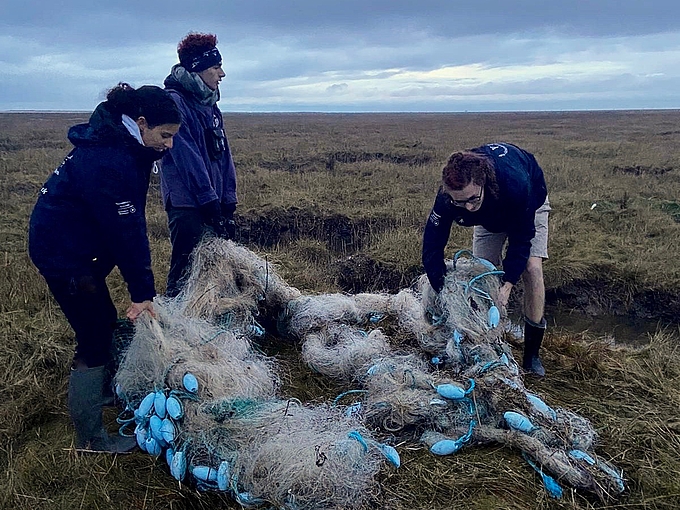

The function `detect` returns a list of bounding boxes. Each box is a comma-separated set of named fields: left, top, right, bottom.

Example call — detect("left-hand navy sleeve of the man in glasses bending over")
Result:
left=423, top=190, right=453, bottom=292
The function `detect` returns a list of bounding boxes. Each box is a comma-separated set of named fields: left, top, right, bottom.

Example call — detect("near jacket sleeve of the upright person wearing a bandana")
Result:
left=168, top=94, right=218, bottom=206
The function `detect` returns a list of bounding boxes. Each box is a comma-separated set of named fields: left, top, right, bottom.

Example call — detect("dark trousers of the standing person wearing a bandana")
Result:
left=165, top=207, right=207, bottom=297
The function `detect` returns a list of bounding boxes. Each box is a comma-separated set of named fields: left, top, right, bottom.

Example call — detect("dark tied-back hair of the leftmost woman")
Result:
left=106, top=82, right=181, bottom=128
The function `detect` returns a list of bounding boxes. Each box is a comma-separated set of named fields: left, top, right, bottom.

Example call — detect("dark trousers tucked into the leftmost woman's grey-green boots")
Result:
left=45, top=267, right=118, bottom=367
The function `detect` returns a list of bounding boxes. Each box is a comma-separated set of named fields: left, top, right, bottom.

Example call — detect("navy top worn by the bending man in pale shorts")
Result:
left=423, top=143, right=548, bottom=292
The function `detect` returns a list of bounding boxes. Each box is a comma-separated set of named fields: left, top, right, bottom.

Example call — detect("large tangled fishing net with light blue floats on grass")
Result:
left=116, top=239, right=625, bottom=509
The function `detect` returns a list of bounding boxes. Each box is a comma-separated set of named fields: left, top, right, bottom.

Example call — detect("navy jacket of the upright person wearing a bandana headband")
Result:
left=161, top=76, right=237, bottom=208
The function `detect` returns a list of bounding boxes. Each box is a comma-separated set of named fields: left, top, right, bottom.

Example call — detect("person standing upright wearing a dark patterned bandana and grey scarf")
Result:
left=161, top=33, right=237, bottom=297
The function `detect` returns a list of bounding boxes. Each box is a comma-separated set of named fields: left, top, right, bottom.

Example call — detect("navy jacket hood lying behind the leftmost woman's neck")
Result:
left=68, top=101, right=163, bottom=161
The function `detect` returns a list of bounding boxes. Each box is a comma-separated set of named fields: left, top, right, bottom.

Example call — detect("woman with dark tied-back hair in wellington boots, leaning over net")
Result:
left=29, top=83, right=180, bottom=453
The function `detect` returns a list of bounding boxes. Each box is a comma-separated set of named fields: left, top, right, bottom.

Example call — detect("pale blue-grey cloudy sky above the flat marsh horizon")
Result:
left=0, top=0, right=680, bottom=112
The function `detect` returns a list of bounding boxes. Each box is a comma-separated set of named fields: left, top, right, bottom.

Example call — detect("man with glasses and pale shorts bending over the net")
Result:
left=423, top=143, right=550, bottom=377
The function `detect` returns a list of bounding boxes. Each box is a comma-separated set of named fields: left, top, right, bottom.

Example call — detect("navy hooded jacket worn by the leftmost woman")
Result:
left=29, top=102, right=162, bottom=303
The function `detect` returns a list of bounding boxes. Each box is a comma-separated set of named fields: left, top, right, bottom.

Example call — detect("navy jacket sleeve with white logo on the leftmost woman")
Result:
left=81, top=149, right=156, bottom=303
